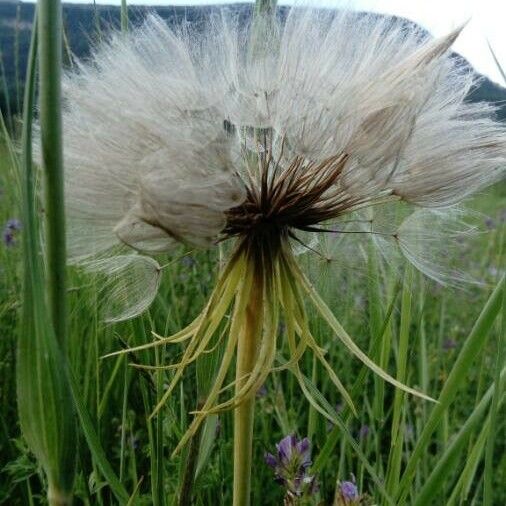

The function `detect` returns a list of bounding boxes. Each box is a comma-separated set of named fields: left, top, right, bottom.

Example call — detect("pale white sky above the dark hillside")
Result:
left=24, top=0, right=506, bottom=85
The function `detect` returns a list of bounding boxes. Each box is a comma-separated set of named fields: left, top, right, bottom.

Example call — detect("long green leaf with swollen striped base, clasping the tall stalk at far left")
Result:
left=16, top=6, right=77, bottom=506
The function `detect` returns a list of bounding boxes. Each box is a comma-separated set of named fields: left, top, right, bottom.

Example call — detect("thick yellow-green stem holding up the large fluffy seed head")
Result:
left=233, top=262, right=264, bottom=506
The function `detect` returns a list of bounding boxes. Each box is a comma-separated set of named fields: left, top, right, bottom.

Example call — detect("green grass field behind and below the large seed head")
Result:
left=0, top=131, right=506, bottom=506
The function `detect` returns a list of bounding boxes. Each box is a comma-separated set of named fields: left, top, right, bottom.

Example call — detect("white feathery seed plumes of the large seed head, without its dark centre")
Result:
left=60, top=9, right=506, bottom=319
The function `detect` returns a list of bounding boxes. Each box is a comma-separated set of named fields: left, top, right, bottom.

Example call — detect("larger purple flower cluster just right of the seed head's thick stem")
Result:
left=265, top=434, right=317, bottom=497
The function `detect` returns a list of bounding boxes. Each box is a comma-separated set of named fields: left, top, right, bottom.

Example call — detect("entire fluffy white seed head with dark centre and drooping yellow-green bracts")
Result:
left=55, top=8, right=506, bottom=444
